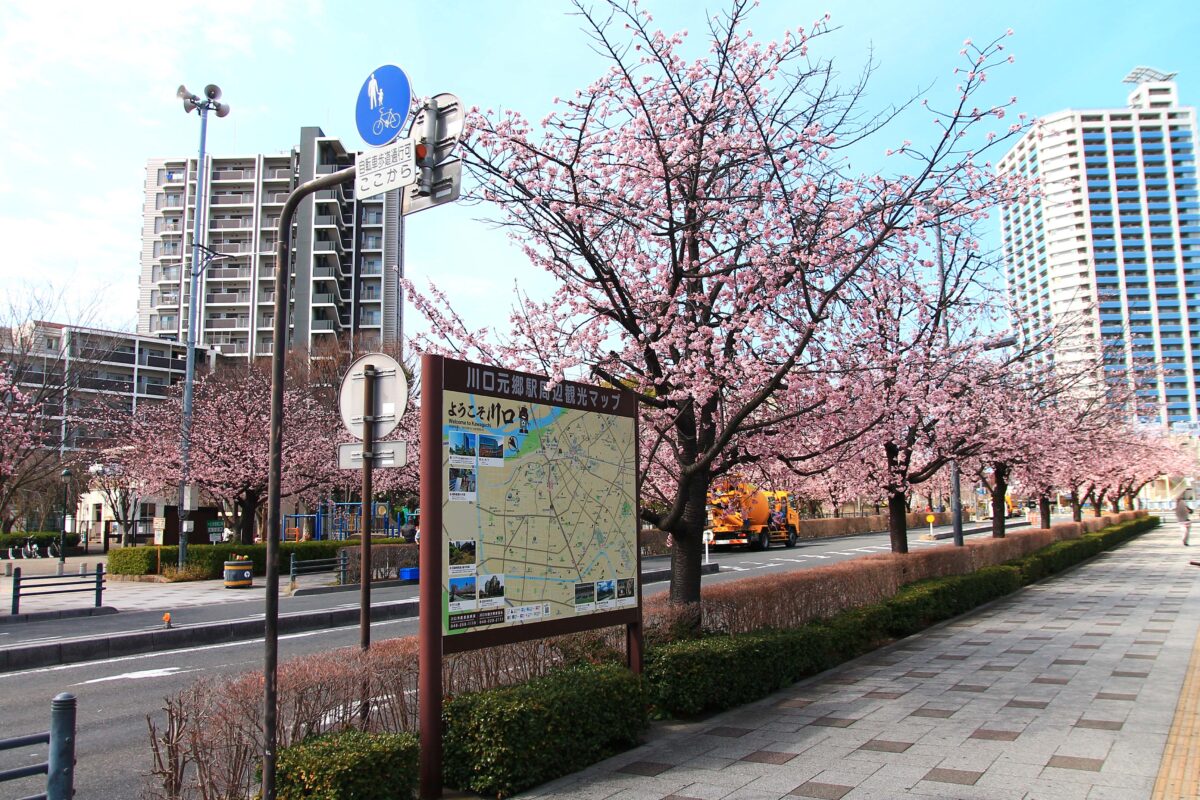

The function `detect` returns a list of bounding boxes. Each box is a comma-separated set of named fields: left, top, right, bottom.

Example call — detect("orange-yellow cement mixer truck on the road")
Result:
left=706, top=481, right=800, bottom=551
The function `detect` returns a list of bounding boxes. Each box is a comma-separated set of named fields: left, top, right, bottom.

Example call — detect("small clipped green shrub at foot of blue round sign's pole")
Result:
left=275, top=728, right=418, bottom=800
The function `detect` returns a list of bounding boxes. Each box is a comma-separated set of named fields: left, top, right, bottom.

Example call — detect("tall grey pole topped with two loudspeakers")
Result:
left=175, top=84, right=229, bottom=570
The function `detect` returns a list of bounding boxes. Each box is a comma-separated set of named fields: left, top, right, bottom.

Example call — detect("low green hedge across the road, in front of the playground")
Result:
left=108, top=539, right=396, bottom=579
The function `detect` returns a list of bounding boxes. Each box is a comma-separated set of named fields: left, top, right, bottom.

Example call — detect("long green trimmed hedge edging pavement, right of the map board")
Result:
left=646, top=517, right=1158, bottom=717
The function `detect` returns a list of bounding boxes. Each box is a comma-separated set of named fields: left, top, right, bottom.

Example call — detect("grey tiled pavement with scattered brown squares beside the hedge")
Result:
left=521, top=524, right=1200, bottom=800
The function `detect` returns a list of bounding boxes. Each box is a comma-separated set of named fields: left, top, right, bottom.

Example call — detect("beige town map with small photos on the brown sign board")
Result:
left=442, top=367, right=637, bottom=636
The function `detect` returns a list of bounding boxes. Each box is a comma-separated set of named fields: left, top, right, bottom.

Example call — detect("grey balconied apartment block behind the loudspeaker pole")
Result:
left=138, top=127, right=401, bottom=359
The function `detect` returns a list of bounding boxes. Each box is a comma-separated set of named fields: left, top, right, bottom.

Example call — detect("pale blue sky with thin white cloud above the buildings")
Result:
left=0, top=0, right=1200, bottom=340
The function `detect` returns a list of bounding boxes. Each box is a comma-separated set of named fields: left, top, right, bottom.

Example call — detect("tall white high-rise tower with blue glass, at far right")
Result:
left=998, top=67, right=1200, bottom=429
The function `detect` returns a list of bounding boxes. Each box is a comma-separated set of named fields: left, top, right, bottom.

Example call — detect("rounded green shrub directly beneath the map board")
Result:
left=442, top=664, right=647, bottom=798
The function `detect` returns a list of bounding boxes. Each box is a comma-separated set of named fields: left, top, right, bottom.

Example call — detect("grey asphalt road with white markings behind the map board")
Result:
left=0, top=525, right=1008, bottom=800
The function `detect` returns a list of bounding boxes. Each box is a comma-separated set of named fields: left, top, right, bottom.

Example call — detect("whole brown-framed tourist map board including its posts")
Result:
left=418, top=355, right=642, bottom=798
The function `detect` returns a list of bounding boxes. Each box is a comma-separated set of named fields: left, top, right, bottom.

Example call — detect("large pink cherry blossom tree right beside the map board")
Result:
left=409, top=0, right=1021, bottom=603
